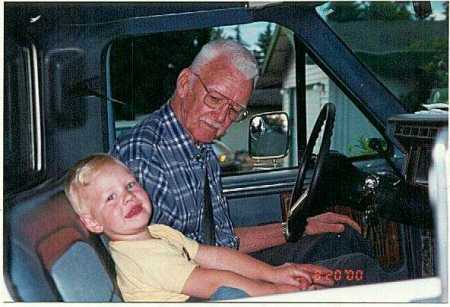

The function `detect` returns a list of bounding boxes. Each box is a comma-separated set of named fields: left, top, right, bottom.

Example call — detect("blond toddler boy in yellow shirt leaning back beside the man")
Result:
left=64, top=154, right=333, bottom=302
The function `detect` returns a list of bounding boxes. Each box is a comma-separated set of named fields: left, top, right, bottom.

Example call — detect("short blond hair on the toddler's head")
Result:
left=64, top=153, right=126, bottom=215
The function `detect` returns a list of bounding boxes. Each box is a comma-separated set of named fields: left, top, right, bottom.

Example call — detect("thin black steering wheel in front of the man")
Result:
left=285, top=103, right=336, bottom=242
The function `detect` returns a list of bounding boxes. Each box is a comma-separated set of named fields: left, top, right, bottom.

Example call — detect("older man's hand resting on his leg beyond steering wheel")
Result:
left=305, top=212, right=361, bottom=235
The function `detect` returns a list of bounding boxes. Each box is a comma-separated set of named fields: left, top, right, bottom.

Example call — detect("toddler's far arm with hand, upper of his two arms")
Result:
left=194, top=245, right=332, bottom=287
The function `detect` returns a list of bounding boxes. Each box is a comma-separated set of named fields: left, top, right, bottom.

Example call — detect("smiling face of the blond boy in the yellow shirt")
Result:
left=81, top=162, right=152, bottom=240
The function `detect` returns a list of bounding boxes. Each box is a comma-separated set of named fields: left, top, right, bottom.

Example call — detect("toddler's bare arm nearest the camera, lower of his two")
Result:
left=182, top=267, right=300, bottom=298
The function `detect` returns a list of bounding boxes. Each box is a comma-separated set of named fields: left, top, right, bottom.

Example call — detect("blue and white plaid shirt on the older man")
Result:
left=110, top=103, right=239, bottom=248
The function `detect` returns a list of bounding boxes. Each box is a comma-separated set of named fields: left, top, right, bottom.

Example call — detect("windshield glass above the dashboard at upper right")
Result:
left=317, top=1, right=448, bottom=112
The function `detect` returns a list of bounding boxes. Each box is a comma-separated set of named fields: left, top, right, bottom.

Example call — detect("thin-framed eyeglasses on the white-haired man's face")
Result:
left=192, top=72, right=248, bottom=122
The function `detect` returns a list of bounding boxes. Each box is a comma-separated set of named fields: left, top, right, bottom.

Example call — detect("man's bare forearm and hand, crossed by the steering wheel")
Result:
left=235, top=212, right=361, bottom=253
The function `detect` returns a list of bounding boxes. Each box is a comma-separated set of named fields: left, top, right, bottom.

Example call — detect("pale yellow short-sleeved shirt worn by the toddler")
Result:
left=109, top=224, right=199, bottom=302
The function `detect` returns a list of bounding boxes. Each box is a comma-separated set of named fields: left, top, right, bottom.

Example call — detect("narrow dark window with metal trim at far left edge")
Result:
left=3, top=46, right=36, bottom=193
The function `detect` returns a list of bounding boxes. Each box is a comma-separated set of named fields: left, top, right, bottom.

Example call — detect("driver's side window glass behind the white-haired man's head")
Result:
left=109, top=22, right=297, bottom=175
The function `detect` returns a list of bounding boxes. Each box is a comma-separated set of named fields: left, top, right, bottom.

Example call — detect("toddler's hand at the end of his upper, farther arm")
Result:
left=271, top=263, right=334, bottom=290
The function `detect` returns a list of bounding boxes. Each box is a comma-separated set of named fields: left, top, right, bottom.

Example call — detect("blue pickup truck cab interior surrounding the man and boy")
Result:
left=3, top=1, right=448, bottom=302
